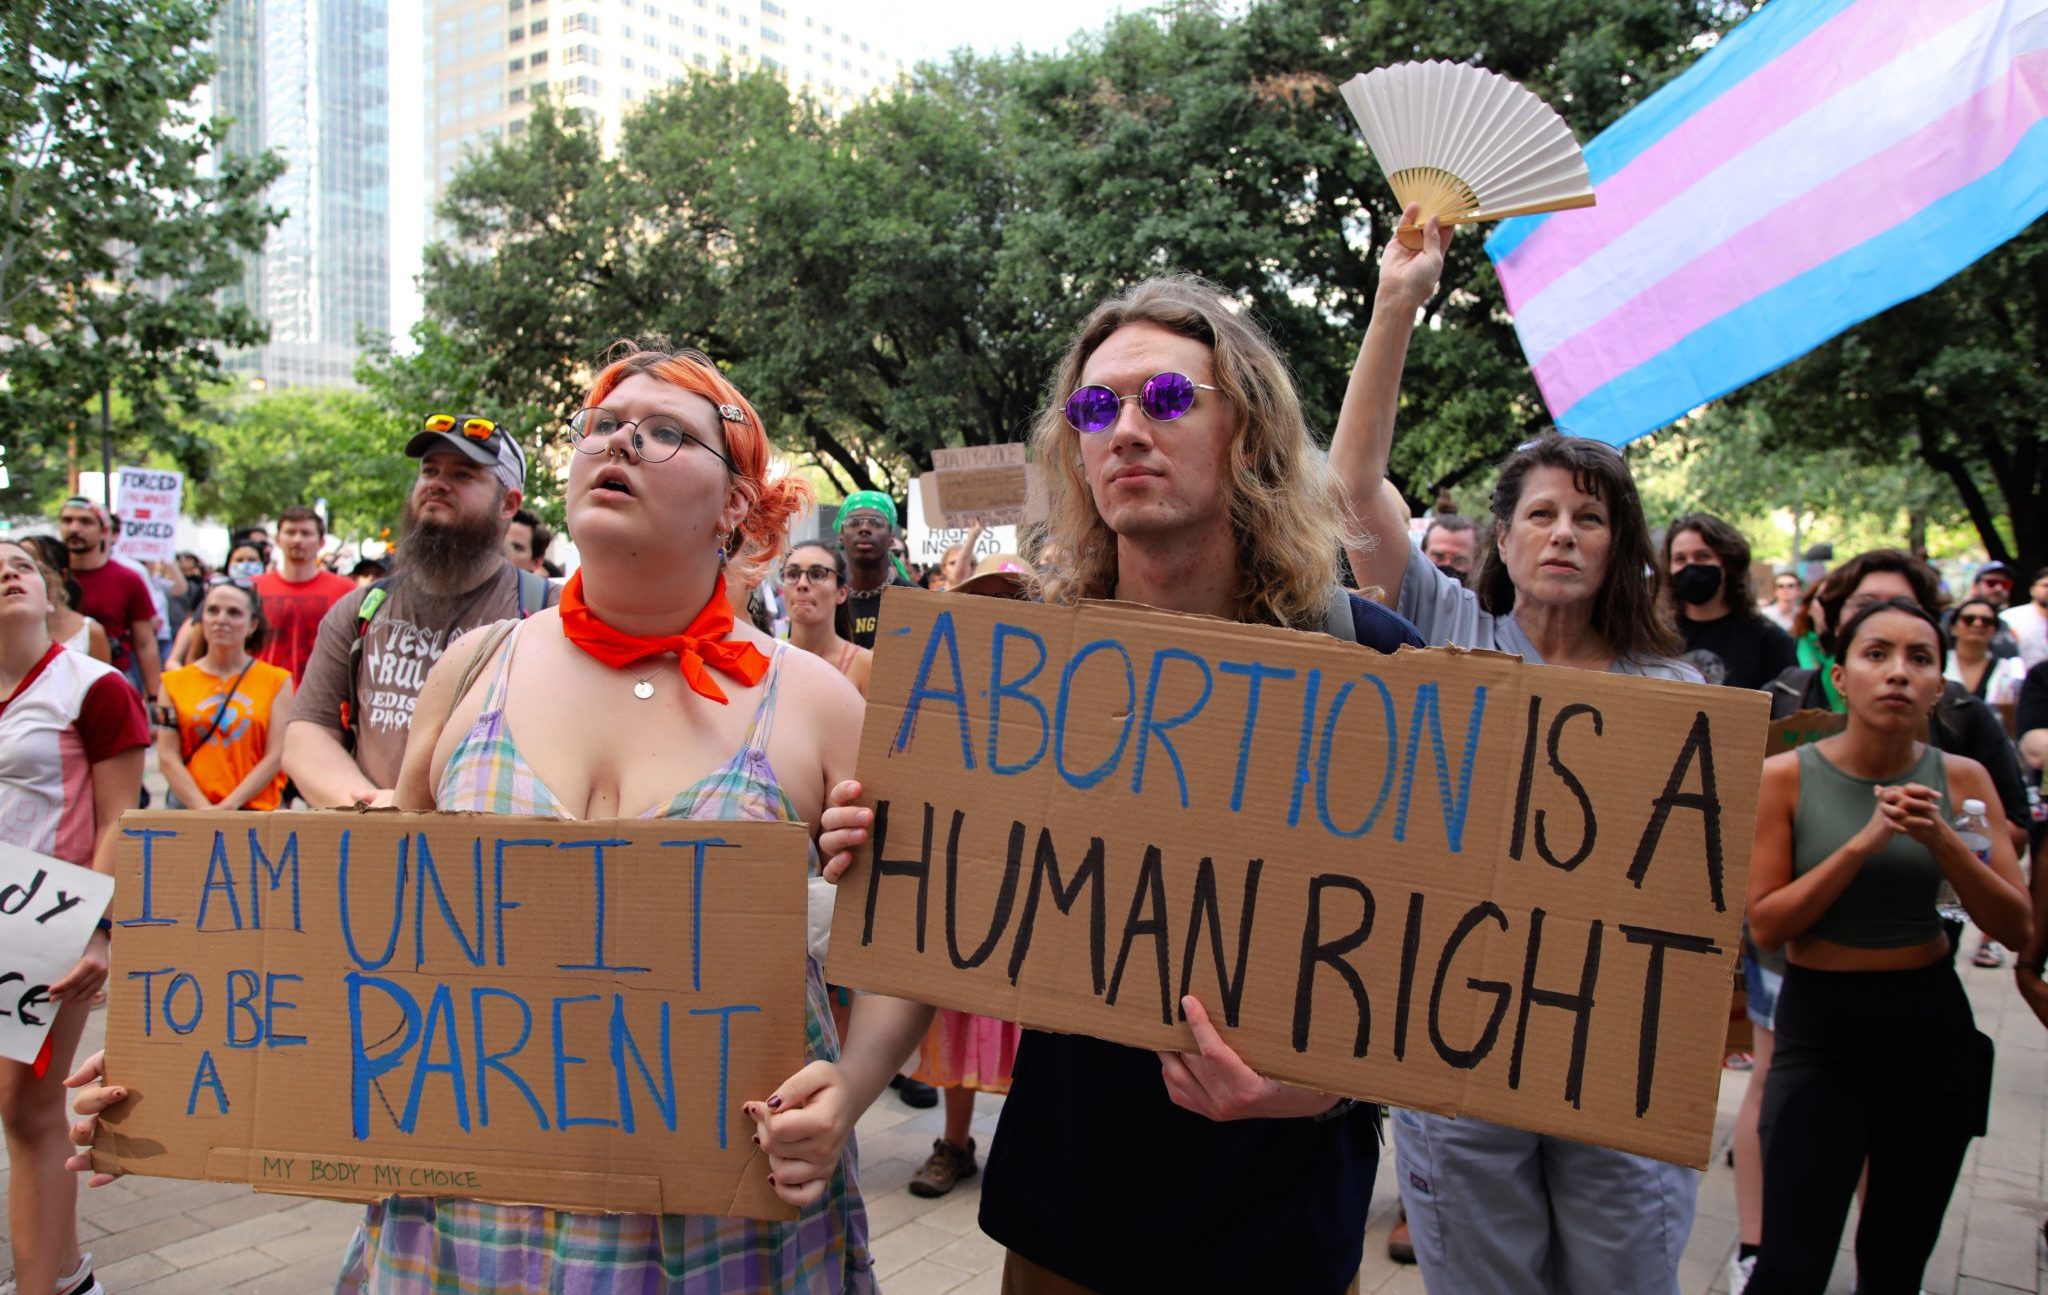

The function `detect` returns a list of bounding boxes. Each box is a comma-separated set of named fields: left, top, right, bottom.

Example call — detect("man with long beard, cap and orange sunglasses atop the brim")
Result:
left=285, top=414, right=555, bottom=805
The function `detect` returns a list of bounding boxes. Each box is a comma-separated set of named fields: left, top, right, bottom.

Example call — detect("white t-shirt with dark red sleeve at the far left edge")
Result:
left=0, top=643, right=150, bottom=867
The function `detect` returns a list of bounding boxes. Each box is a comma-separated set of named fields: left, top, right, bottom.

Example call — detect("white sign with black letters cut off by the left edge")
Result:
left=0, top=842, right=115, bottom=1066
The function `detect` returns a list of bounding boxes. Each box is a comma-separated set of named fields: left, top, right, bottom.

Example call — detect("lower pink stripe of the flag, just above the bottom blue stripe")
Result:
left=1536, top=51, right=2048, bottom=410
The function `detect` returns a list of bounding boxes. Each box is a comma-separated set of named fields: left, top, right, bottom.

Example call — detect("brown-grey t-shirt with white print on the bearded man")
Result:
left=291, top=561, right=520, bottom=787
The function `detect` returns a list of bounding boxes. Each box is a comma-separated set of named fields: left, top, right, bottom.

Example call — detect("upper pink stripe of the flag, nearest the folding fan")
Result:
left=1499, top=0, right=1999, bottom=309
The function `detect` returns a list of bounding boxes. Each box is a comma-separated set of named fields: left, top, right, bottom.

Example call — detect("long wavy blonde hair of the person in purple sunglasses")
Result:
left=1032, top=275, right=1346, bottom=629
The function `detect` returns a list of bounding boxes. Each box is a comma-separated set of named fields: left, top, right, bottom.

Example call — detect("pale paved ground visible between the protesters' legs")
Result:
left=0, top=942, right=2048, bottom=1295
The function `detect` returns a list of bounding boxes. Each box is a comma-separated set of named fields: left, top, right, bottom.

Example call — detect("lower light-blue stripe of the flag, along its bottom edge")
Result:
left=1556, top=121, right=2048, bottom=445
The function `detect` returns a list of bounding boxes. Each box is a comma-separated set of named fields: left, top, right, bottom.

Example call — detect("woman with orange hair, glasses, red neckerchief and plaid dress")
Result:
left=342, top=350, right=930, bottom=1293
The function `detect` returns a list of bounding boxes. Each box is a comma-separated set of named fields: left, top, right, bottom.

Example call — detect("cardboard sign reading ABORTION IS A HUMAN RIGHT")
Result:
left=829, top=588, right=1769, bottom=1166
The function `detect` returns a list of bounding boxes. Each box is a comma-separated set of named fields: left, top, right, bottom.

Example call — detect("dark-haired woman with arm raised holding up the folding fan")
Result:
left=1329, top=209, right=1700, bottom=1295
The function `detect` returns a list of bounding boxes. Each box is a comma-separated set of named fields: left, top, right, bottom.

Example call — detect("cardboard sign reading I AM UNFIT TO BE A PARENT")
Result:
left=92, top=811, right=807, bottom=1219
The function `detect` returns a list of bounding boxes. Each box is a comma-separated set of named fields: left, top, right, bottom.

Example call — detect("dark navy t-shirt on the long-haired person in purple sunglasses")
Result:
left=981, top=594, right=1423, bottom=1295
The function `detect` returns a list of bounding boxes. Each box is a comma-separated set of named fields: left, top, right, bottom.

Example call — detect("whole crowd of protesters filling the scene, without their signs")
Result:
left=0, top=210, right=2048, bottom=1295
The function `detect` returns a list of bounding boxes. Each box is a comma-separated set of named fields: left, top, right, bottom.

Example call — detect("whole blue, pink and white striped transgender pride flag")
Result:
left=1487, top=0, right=2048, bottom=445
